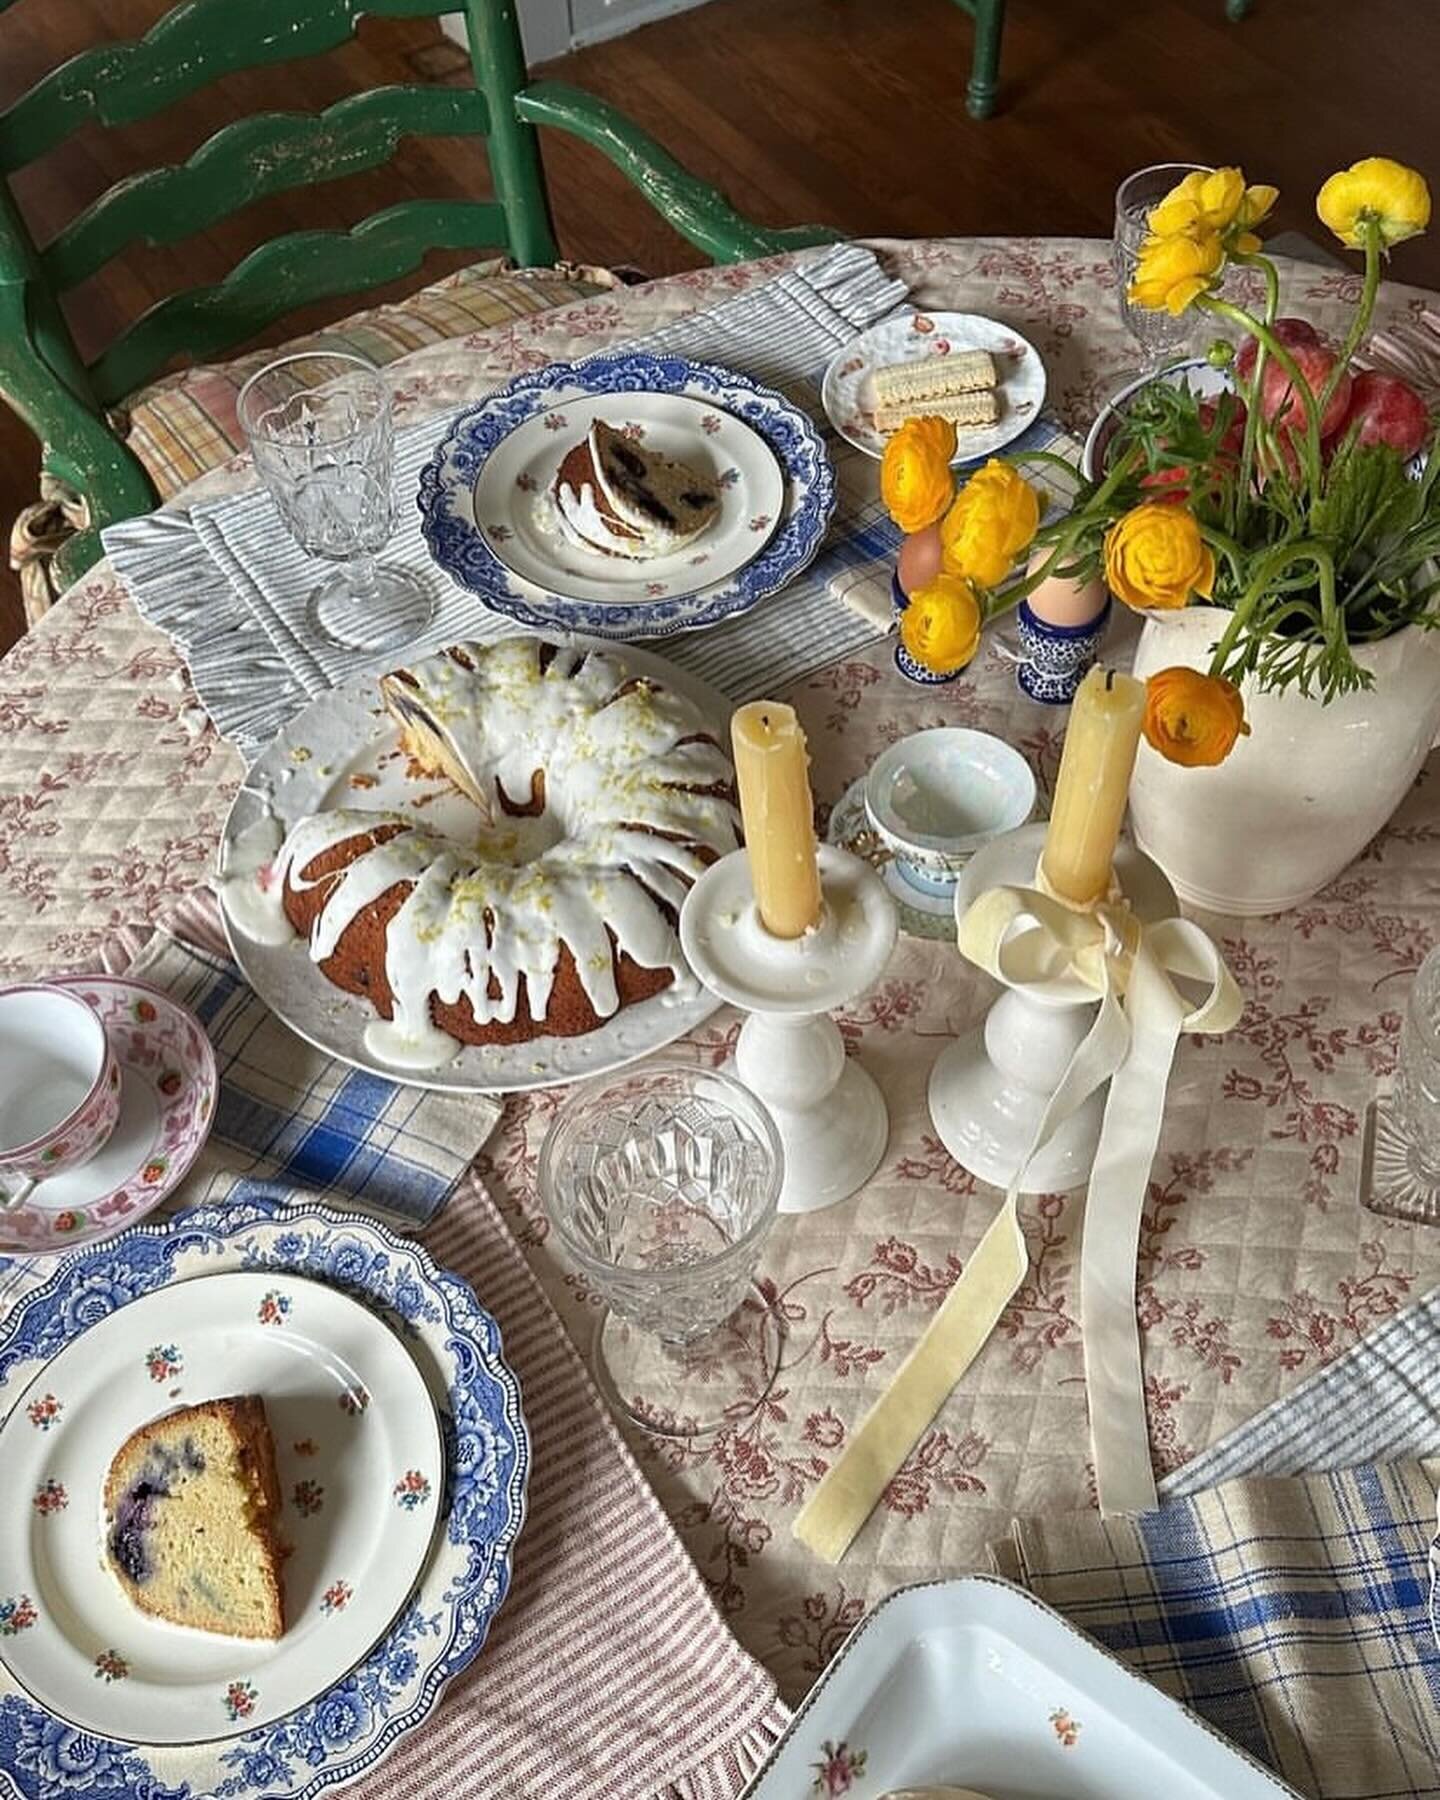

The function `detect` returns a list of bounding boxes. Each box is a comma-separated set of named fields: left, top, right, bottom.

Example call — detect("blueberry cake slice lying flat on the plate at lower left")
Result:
left=104, top=1393, right=286, bottom=1638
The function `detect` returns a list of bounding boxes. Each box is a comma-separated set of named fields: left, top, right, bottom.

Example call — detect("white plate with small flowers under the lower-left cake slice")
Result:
left=0, top=1273, right=445, bottom=1744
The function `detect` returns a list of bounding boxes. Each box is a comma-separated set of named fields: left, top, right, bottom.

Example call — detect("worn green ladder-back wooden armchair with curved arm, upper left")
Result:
left=0, top=0, right=837, bottom=604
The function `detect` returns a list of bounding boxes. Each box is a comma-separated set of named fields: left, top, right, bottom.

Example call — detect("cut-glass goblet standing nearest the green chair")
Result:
left=236, top=351, right=436, bottom=650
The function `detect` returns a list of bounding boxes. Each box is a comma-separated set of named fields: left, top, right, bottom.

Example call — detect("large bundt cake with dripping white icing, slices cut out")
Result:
left=255, top=637, right=740, bottom=1067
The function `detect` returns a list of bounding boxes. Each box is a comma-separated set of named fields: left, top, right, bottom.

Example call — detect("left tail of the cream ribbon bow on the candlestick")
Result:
left=792, top=992, right=1129, bottom=1562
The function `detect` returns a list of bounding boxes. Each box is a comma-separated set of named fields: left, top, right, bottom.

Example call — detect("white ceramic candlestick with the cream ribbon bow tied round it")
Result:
left=929, top=824, right=1179, bottom=1193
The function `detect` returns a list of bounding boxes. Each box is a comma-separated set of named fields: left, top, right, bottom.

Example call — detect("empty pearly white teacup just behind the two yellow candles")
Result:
left=866, top=725, right=1035, bottom=898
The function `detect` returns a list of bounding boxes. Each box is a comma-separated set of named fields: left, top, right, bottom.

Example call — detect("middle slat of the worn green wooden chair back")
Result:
left=40, top=86, right=490, bottom=290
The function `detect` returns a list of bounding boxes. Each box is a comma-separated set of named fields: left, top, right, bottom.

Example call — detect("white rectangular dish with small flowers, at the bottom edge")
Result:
left=742, top=1575, right=1298, bottom=1800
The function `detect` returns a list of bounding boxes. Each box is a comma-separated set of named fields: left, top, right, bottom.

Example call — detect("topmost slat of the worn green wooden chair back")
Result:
left=0, top=0, right=455, bottom=173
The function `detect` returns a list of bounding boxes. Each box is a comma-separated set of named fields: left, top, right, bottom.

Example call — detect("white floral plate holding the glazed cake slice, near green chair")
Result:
left=475, top=394, right=785, bottom=605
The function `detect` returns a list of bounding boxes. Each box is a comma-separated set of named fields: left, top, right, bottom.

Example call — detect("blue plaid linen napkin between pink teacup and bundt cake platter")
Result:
left=0, top=932, right=500, bottom=1309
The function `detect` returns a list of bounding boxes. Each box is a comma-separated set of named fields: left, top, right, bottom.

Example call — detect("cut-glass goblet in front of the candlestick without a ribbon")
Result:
left=540, top=1062, right=785, bottom=1436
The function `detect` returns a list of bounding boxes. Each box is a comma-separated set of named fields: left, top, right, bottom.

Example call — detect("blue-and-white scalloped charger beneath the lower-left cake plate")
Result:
left=0, top=1184, right=529, bottom=1800
